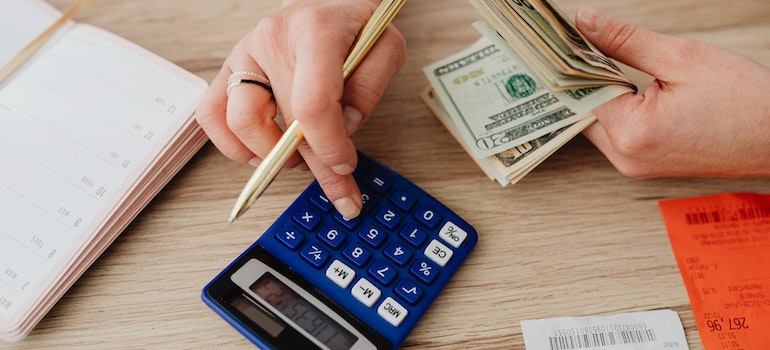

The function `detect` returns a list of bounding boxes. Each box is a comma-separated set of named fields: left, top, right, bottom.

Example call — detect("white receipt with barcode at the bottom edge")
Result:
left=521, top=310, right=688, bottom=350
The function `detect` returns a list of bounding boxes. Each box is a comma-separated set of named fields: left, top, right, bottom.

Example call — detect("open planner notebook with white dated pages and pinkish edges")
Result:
left=0, top=0, right=206, bottom=341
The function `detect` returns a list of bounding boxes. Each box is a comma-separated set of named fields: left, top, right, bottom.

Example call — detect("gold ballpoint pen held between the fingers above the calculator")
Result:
left=229, top=0, right=406, bottom=222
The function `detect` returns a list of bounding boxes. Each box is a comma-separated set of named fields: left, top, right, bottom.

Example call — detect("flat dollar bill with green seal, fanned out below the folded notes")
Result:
left=424, top=34, right=629, bottom=158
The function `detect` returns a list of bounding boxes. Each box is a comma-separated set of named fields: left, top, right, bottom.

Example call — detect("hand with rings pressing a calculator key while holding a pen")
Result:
left=196, top=0, right=406, bottom=218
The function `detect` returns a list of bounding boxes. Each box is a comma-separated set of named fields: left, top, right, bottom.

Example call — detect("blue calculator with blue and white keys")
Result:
left=202, top=152, right=478, bottom=350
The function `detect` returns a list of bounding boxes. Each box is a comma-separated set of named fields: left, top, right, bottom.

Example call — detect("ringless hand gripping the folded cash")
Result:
left=576, top=8, right=770, bottom=179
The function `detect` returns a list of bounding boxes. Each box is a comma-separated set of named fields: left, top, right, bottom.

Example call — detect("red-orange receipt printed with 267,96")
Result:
left=659, top=193, right=770, bottom=350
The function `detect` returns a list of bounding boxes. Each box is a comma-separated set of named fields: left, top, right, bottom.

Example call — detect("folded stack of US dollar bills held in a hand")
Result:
left=421, top=0, right=636, bottom=186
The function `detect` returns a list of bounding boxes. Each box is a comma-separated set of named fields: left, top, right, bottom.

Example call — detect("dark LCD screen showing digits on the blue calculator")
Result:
left=251, top=272, right=358, bottom=350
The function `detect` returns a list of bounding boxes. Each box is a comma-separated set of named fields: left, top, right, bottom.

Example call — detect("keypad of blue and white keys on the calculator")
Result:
left=266, top=154, right=475, bottom=334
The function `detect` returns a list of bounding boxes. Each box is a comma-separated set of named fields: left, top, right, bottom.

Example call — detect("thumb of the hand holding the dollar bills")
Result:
left=575, top=7, right=678, bottom=78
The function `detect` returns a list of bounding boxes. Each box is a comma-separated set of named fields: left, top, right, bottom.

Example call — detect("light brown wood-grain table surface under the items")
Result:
left=6, top=0, right=770, bottom=349
